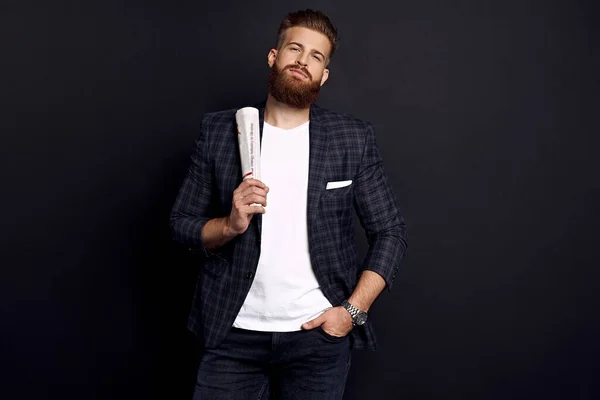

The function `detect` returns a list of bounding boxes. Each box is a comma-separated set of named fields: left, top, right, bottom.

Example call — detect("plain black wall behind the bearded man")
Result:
left=0, top=0, right=600, bottom=399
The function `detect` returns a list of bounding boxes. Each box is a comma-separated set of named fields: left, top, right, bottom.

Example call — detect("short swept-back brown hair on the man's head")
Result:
left=276, top=9, right=339, bottom=58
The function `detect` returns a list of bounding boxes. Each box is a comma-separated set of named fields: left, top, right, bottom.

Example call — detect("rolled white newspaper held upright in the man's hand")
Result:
left=235, top=107, right=260, bottom=180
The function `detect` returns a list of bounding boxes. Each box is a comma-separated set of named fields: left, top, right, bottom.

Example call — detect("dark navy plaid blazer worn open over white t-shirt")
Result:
left=170, top=102, right=407, bottom=350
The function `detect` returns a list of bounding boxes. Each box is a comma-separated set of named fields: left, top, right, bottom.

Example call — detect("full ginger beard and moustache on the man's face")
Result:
left=267, top=63, right=321, bottom=109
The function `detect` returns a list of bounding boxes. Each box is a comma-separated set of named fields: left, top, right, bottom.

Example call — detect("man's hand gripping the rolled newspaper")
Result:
left=227, top=178, right=269, bottom=236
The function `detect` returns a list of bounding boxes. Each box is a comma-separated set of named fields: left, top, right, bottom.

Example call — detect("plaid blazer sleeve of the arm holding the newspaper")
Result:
left=170, top=115, right=214, bottom=256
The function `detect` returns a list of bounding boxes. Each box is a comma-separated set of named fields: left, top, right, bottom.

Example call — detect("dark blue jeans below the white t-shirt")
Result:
left=194, top=328, right=351, bottom=400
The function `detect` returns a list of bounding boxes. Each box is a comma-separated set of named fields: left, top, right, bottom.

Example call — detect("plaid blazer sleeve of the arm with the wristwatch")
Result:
left=354, top=124, right=407, bottom=290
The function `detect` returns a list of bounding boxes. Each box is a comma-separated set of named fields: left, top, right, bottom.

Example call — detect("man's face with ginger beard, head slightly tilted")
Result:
left=268, top=27, right=331, bottom=108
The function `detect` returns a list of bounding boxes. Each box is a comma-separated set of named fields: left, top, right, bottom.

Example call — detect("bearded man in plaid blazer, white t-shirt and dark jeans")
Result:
left=171, top=10, right=406, bottom=399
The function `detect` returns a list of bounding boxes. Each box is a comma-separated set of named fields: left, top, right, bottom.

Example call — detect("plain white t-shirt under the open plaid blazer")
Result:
left=233, top=122, right=331, bottom=332
